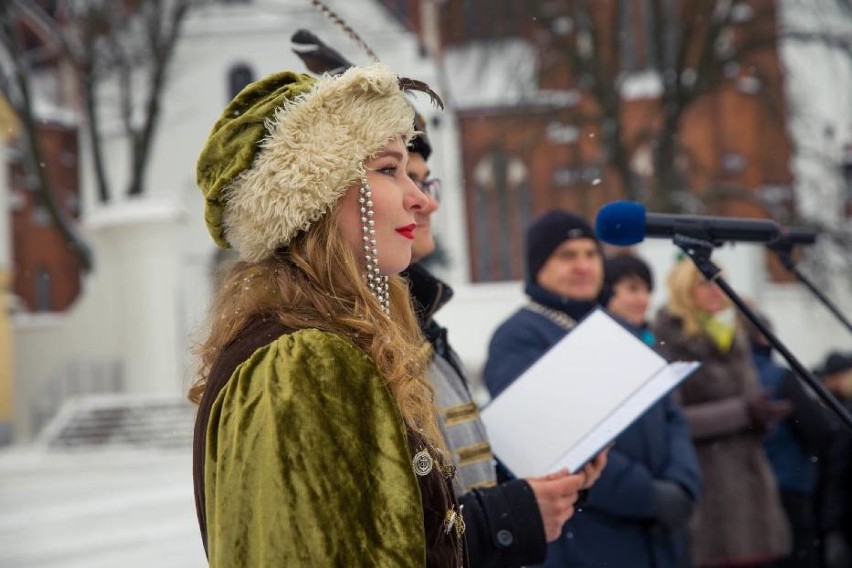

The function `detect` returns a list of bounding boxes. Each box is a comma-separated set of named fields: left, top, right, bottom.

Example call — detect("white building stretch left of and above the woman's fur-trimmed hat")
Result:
left=13, top=0, right=451, bottom=440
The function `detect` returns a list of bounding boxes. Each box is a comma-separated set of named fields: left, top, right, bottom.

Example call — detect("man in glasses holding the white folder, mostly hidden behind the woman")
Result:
left=403, top=130, right=606, bottom=568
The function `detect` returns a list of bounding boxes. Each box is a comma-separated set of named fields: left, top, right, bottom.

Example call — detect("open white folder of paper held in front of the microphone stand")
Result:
left=482, top=309, right=698, bottom=477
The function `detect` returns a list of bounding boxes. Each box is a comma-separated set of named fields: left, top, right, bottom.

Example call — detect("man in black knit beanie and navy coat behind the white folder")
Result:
left=485, top=214, right=700, bottom=568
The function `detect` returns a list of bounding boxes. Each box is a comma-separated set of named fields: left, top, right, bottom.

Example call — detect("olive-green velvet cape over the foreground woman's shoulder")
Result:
left=203, top=329, right=461, bottom=568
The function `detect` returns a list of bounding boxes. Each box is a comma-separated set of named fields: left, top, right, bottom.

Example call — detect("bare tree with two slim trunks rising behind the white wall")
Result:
left=12, top=0, right=205, bottom=203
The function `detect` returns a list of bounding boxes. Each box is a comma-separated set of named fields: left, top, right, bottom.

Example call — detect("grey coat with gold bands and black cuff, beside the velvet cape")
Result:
left=403, top=264, right=547, bottom=568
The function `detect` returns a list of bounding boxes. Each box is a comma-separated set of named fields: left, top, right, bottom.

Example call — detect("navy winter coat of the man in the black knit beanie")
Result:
left=485, top=284, right=699, bottom=568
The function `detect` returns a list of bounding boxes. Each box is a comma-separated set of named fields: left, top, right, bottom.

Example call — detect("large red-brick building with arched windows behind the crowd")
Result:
left=383, top=0, right=793, bottom=282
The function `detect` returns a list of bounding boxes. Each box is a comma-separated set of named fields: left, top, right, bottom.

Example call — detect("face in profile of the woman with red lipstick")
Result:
left=337, top=140, right=428, bottom=274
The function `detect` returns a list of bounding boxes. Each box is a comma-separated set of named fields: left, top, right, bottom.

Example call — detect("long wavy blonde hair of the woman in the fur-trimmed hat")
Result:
left=188, top=202, right=445, bottom=449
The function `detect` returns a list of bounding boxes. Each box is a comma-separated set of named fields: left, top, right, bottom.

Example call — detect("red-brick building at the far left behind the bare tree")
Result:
left=0, top=5, right=82, bottom=312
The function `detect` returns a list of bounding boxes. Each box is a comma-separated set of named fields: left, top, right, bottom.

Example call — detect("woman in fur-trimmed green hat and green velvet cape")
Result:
left=190, top=64, right=465, bottom=567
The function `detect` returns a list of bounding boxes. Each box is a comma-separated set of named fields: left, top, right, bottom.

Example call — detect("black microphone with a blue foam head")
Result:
left=595, top=201, right=784, bottom=246
